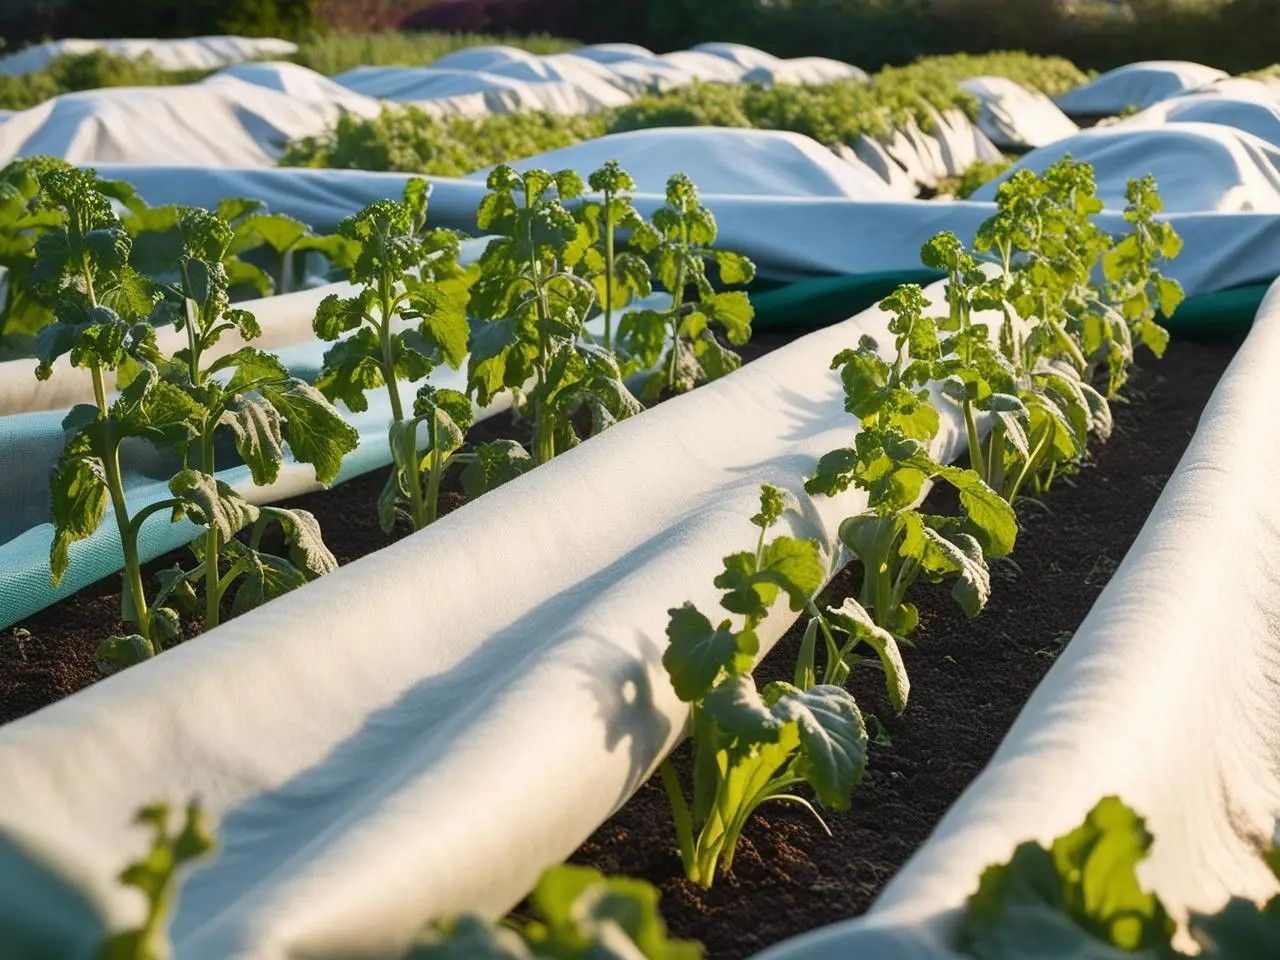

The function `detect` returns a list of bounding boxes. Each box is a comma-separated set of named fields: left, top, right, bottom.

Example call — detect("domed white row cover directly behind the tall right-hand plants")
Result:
left=973, top=123, right=1280, bottom=212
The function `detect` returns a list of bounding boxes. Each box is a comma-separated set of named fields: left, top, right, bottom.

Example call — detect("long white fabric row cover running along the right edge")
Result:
left=758, top=277, right=1280, bottom=960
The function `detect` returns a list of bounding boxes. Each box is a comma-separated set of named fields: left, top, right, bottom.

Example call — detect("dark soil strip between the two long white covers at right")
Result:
left=572, top=342, right=1234, bottom=960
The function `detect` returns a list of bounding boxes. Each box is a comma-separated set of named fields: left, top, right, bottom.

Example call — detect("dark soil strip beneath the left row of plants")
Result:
left=0, top=328, right=809, bottom=724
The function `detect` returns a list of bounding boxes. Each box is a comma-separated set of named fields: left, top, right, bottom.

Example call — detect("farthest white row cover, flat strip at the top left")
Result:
left=0, top=37, right=298, bottom=77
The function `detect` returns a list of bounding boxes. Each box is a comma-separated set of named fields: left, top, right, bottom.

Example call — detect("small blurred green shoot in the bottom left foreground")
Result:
left=96, top=801, right=214, bottom=960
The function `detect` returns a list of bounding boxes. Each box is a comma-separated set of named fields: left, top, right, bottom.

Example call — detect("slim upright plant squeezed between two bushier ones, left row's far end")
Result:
left=573, top=160, right=652, bottom=351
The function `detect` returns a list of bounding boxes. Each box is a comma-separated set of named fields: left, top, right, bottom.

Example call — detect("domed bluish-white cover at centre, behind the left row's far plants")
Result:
left=467, top=127, right=896, bottom=201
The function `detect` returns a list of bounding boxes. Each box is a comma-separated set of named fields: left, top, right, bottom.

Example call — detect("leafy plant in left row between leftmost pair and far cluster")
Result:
left=314, top=179, right=471, bottom=531
